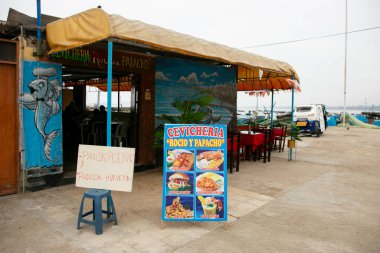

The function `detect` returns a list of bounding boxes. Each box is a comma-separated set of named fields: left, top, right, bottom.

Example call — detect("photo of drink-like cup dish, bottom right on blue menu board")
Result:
left=195, top=196, right=224, bottom=219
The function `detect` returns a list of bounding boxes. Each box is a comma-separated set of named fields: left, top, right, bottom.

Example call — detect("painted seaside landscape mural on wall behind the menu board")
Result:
left=155, top=57, right=237, bottom=127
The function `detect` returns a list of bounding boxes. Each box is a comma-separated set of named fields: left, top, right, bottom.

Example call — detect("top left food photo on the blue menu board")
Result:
left=166, top=149, right=194, bottom=171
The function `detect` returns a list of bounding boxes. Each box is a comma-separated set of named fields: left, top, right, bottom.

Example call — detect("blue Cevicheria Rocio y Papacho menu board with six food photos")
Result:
left=162, top=124, right=227, bottom=221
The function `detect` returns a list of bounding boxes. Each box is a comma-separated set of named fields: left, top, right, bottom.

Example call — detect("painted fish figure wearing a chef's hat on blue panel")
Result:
left=22, top=68, right=61, bottom=161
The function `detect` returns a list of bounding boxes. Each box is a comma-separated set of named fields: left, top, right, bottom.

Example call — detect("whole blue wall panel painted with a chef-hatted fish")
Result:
left=21, top=61, right=62, bottom=169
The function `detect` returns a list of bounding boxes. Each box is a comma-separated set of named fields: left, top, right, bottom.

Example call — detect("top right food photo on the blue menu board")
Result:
left=196, top=150, right=224, bottom=170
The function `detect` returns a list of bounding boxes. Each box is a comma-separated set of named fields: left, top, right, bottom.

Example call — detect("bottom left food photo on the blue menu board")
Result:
left=165, top=196, right=194, bottom=219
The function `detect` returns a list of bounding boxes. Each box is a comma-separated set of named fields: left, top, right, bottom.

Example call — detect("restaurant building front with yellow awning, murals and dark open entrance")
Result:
left=0, top=9, right=298, bottom=195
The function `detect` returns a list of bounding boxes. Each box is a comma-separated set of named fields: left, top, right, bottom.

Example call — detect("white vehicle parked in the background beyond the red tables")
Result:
left=293, top=104, right=326, bottom=137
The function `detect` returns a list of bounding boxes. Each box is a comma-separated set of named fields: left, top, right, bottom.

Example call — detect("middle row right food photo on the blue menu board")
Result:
left=196, top=172, right=224, bottom=194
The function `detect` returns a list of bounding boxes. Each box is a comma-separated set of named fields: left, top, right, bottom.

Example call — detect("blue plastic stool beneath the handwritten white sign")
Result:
left=77, top=189, right=117, bottom=235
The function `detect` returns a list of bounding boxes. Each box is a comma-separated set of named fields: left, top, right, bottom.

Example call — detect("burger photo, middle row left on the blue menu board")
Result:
left=166, top=172, right=194, bottom=194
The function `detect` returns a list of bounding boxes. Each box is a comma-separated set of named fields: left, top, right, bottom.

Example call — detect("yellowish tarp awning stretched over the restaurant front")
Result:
left=46, top=9, right=299, bottom=90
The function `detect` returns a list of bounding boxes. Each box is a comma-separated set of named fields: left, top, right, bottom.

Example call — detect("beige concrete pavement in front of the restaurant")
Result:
left=0, top=127, right=380, bottom=253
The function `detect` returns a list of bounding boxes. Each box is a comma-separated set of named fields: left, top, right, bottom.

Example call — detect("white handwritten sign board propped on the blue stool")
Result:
left=75, top=145, right=135, bottom=192
